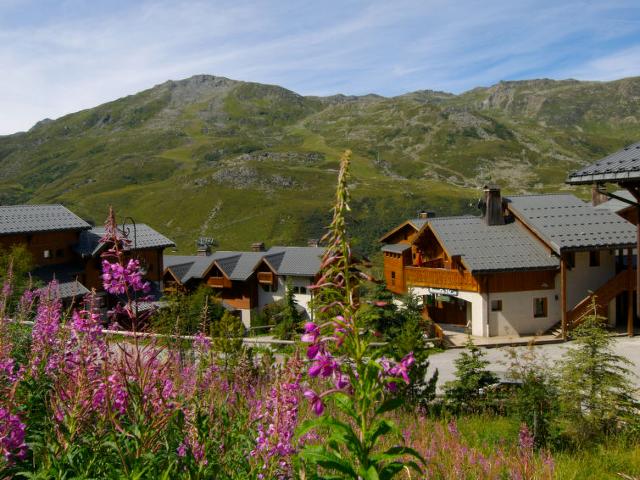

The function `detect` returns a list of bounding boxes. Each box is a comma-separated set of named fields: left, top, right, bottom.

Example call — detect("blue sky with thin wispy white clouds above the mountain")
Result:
left=0, top=0, right=640, bottom=135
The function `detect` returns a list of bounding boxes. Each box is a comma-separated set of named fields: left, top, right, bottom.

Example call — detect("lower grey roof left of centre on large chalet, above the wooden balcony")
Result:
left=429, top=216, right=560, bottom=273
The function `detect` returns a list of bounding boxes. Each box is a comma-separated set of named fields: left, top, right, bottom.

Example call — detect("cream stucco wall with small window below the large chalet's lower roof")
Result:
left=489, top=290, right=561, bottom=336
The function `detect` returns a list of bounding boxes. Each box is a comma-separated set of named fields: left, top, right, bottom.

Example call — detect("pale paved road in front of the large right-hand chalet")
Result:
left=429, top=337, right=640, bottom=391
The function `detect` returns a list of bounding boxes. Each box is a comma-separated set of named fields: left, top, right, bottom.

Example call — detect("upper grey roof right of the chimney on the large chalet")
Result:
left=507, top=194, right=636, bottom=253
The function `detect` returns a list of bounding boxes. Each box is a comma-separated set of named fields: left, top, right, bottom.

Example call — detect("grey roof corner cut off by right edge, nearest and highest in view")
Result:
left=567, top=142, right=640, bottom=185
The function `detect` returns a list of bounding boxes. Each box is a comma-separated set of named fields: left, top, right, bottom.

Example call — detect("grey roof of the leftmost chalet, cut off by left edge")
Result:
left=0, top=205, right=91, bottom=235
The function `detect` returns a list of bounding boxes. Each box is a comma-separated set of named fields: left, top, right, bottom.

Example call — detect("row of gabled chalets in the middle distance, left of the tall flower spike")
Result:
left=163, top=247, right=324, bottom=328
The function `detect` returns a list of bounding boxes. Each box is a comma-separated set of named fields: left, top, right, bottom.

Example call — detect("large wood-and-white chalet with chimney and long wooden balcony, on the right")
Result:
left=381, top=186, right=636, bottom=337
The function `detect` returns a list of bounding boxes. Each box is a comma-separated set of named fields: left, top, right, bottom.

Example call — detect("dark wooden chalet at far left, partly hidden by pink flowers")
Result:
left=0, top=205, right=175, bottom=300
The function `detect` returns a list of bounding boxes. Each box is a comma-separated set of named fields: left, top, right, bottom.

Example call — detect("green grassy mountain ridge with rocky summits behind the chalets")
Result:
left=0, top=75, right=640, bottom=252
